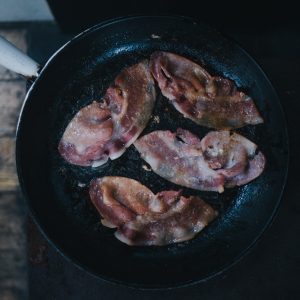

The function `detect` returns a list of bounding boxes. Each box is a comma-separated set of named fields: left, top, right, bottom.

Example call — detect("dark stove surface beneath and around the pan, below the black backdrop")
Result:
left=28, top=24, right=300, bottom=300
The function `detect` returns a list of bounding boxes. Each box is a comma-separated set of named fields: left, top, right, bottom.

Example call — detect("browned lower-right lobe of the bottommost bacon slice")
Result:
left=115, top=196, right=217, bottom=246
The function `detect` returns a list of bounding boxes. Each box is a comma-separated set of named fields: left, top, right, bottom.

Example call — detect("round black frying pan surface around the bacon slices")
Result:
left=1, top=17, right=288, bottom=288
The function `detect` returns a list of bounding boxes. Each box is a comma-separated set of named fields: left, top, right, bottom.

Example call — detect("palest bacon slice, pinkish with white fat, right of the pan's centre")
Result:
left=134, top=129, right=265, bottom=193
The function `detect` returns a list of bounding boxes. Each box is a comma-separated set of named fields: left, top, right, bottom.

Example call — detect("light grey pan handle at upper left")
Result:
left=0, top=36, right=40, bottom=78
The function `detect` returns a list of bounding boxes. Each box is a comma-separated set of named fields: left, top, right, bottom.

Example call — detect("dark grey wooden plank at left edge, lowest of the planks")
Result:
left=0, top=191, right=27, bottom=300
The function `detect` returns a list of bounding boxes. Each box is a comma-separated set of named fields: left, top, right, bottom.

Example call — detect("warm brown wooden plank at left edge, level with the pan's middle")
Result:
left=0, top=137, right=19, bottom=192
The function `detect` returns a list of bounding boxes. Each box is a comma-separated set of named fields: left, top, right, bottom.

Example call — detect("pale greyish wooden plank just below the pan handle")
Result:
left=0, top=80, right=25, bottom=137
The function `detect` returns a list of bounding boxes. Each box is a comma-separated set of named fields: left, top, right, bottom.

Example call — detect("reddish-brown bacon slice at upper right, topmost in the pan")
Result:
left=150, top=52, right=263, bottom=129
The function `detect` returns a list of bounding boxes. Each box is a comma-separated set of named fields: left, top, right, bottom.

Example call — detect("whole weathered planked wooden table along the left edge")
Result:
left=0, top=28, right=27, bottom=300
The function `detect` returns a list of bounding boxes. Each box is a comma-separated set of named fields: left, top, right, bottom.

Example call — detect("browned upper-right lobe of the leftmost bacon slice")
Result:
left=105, top=61, right=156, bottom=159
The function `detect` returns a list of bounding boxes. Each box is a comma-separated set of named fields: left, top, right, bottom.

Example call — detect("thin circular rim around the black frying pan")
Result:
left=15, top=15, right=290, bottom=290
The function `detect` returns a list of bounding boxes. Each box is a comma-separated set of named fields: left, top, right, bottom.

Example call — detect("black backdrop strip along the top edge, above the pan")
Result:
left=47, top=0, right=299, bottom=33
